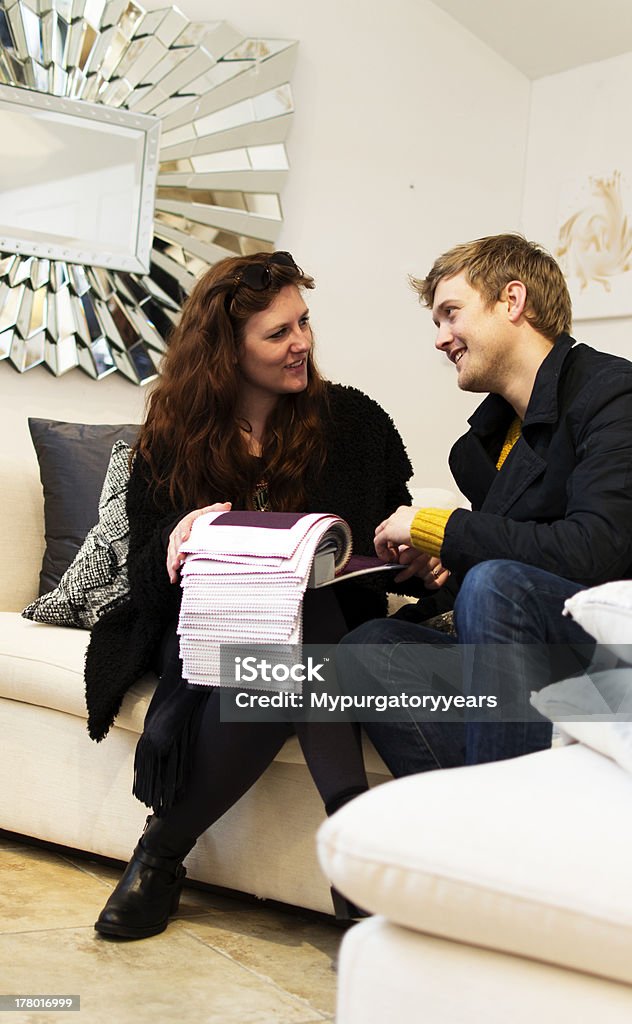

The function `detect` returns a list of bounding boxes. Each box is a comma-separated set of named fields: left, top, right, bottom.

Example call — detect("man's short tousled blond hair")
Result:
left=411, top=233, right=573, bottom=341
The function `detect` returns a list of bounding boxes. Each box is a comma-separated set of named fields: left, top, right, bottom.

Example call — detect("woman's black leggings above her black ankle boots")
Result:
left=145, top=588, right=368, bottom=852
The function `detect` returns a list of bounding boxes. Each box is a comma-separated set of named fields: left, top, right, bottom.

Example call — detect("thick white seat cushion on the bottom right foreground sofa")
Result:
left=319, top=744, right=632, bottom=983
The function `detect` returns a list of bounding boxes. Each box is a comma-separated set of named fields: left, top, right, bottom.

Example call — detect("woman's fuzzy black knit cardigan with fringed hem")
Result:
left=85, top=384, right=416, bottom=740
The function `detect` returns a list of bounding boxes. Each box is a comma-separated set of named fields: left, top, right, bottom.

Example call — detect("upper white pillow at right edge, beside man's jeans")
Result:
left=564, top=580, right=632, bottom=665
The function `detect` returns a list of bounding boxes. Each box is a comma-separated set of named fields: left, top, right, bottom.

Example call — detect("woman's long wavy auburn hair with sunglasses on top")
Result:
left=136, top=253, right=327, bottom=511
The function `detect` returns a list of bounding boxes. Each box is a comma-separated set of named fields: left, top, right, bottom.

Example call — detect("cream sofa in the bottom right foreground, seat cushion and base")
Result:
left=319, top=720, right=632, bottom=1024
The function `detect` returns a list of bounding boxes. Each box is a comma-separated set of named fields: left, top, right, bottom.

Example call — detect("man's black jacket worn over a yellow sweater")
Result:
left=441, top=335, right=632, bottom=586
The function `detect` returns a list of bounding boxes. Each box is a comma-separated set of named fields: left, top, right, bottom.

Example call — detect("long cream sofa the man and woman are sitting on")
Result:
left=0, top=385, right=456, bottom=913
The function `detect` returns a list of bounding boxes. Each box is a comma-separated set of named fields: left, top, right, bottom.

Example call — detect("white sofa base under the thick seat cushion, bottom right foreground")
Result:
left=336, top=918, right=632, bottom=1024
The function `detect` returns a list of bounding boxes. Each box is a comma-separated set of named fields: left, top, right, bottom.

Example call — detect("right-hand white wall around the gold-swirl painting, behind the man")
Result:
left=522, top=53, right=632, bottom=358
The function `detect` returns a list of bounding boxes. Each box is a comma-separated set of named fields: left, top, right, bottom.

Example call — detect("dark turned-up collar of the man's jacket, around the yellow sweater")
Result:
left=467, top=334, right=575, bottom=437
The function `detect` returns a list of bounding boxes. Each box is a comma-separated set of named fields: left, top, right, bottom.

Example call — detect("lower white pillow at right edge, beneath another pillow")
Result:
left=531, top=666, right=632, bottom=772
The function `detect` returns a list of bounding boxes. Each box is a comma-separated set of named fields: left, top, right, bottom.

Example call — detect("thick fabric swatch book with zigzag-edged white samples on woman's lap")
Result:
left=178, top=512, right=351, bottom=686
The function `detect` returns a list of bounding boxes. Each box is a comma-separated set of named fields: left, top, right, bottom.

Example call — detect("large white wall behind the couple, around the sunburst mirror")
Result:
left=0, top=0, right=530, bottom=486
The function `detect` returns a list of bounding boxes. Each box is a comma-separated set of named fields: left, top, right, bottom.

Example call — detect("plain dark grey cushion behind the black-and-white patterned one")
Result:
left=29, top=418, right=138, bottom=594
